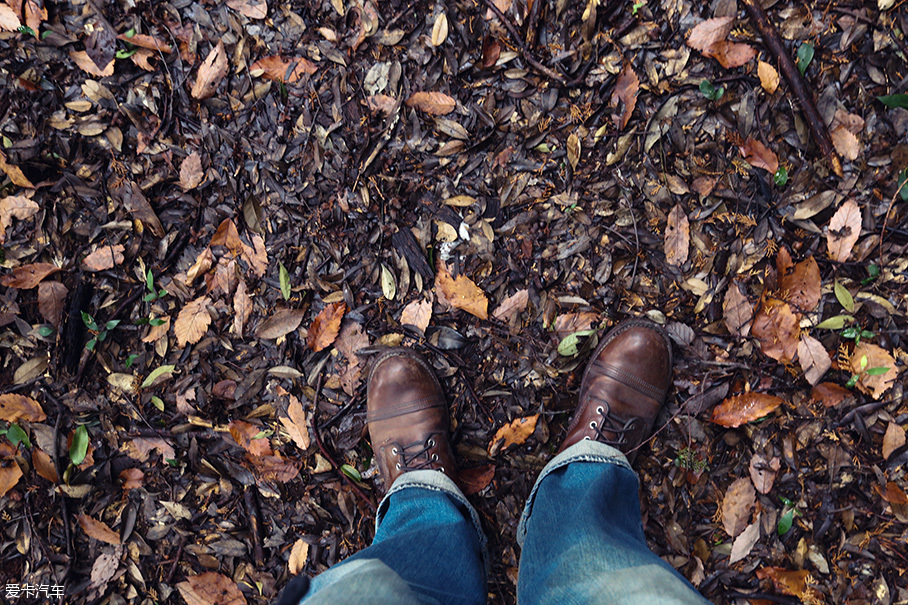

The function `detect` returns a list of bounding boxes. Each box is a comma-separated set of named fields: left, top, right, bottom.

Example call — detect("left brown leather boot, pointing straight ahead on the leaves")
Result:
left=366, top=347, right=455, bottom=489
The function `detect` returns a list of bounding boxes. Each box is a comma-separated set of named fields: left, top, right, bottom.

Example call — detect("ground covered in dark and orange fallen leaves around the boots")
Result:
left=0, top=0, right=908, bottom=603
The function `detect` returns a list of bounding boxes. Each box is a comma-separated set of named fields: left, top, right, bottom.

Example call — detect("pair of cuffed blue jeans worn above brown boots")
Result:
left=288, top=441, right=708, bottom=605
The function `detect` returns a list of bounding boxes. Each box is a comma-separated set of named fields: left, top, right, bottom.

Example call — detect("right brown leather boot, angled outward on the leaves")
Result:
left=559, top=319, right=672, bottom=464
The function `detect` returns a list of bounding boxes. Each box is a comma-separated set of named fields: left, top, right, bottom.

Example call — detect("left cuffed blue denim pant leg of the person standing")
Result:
left=301, top=471, right=488, bottom=605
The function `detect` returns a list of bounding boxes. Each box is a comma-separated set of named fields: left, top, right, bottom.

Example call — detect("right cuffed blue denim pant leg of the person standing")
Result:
left=517, top=441, right=708, bottom=605
